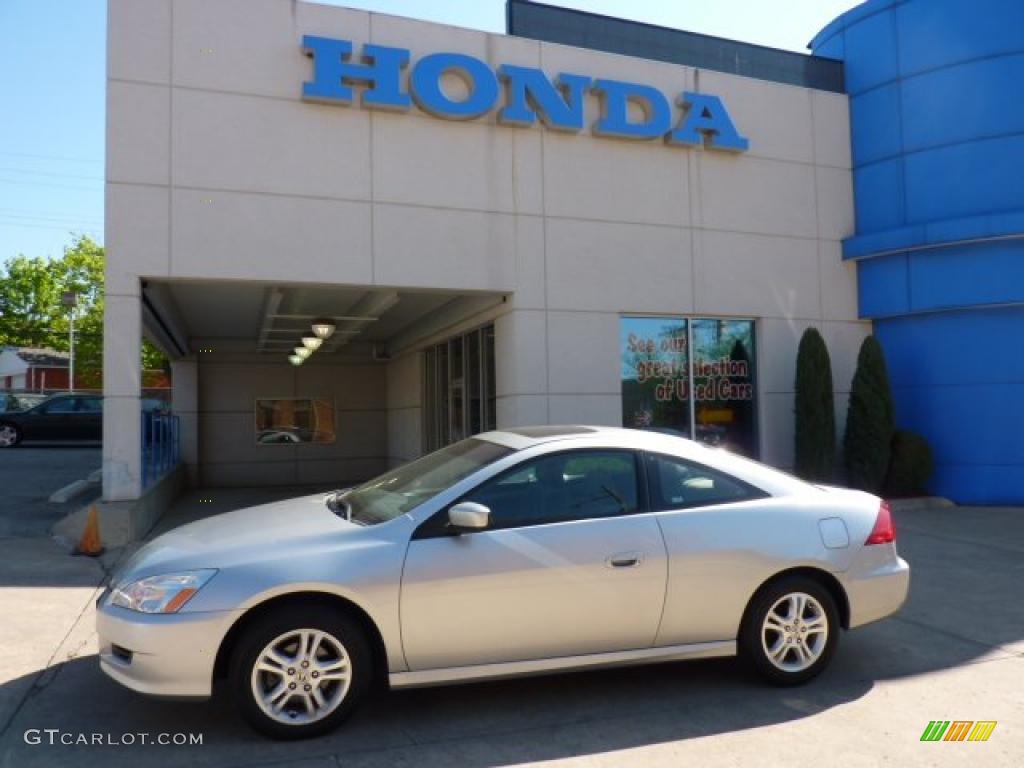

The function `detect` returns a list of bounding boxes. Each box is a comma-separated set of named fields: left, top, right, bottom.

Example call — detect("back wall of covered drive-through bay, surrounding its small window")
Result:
left=198, top=356, right=388, bottom=487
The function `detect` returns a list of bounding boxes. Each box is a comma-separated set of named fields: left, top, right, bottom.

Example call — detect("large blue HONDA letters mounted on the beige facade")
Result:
left=302, top=35, right=750, bottom=152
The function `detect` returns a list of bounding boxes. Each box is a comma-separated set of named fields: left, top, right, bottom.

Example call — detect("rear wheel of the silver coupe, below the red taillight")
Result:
left=739, top=575, right=840, bottom=686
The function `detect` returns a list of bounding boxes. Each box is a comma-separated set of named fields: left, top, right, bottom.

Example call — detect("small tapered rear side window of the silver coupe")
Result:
left=647, top=454, right=766, bottom=511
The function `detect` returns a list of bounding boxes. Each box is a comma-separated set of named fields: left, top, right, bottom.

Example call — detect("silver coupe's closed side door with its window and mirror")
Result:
left=400, top=450, right=667, bottom=671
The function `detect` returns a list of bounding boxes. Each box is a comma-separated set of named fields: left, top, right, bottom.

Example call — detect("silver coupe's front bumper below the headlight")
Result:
left=96, top=595, right=242, bottom=698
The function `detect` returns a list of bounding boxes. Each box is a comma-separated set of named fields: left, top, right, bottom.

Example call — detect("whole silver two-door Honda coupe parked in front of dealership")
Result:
left=96, top=427, right=909, bottom=738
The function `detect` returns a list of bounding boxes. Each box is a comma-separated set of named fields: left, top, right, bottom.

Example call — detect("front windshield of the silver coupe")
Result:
left=329, top=437, right=512, bottom=525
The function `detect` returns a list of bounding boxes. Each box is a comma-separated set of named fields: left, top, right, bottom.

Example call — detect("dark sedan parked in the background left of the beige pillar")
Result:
left=0, top=394, right=103, bottom=449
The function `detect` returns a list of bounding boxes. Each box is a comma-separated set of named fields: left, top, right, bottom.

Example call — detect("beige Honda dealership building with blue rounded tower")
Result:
left=103, top=0, right=1024, bottom=528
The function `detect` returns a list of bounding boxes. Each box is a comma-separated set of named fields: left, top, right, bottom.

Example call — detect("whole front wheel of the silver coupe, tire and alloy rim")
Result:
left=230, top=605, right=373, bottom=739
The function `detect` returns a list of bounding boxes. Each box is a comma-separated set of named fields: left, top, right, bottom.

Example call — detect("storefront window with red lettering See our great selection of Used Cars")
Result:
left=620, top=317, right=758, bottom=457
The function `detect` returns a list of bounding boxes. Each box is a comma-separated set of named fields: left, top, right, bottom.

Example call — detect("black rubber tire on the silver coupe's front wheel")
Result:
left=228, top=603, right=374, bottom=739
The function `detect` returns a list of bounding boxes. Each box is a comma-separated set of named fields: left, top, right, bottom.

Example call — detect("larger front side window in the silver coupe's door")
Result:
left=463, top=451, right=639, bottom=529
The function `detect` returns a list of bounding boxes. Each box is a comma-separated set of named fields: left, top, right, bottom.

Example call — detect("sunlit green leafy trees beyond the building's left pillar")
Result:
left=0, top=236, right=166, bottom=379
